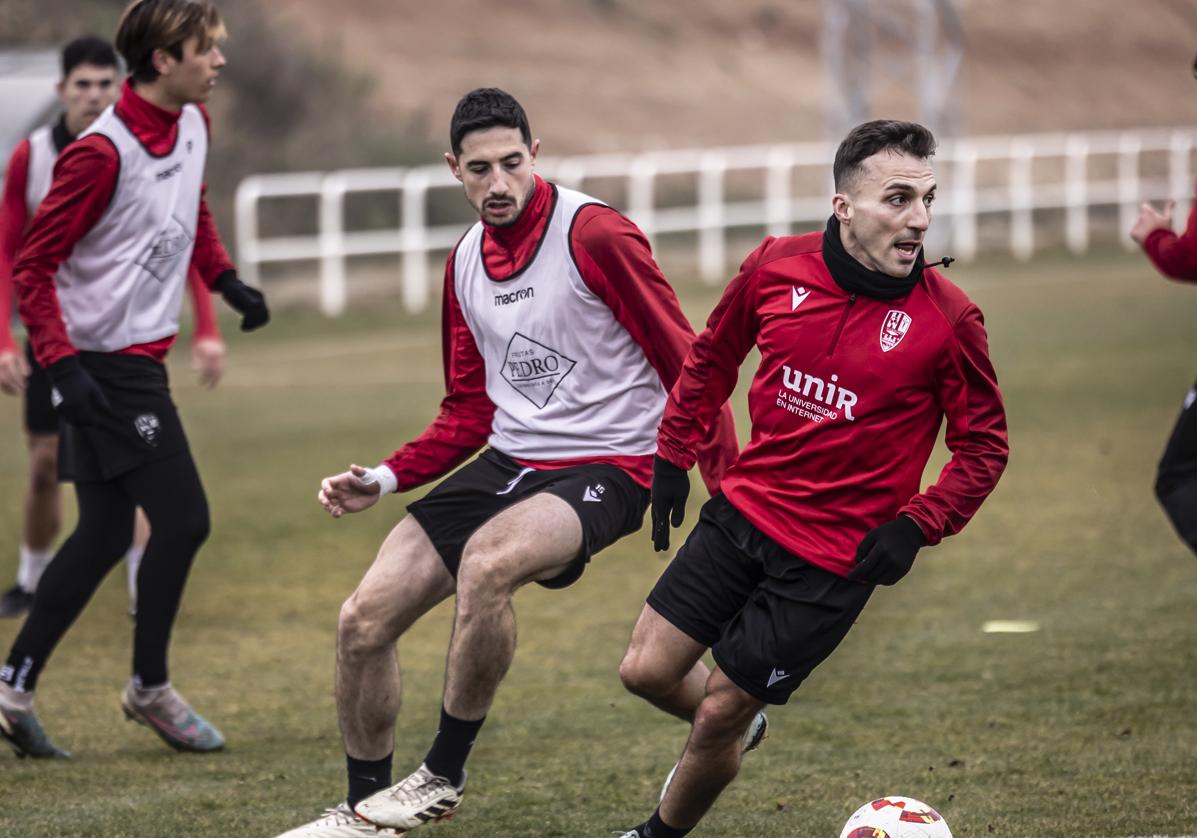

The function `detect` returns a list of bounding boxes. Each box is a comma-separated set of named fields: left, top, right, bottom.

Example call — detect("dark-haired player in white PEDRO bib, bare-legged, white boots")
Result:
left=287, top=89, right=737, bottom=838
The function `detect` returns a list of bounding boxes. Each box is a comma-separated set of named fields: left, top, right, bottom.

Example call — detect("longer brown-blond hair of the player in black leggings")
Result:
left=115, top=0, right=225, bottom=81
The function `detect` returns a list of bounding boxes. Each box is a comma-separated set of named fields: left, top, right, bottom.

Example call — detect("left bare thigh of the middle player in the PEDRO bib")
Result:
left=341, top=515, right=455, bottom=637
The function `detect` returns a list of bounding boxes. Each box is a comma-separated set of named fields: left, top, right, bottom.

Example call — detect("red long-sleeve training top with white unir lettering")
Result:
left=658, top=233, right=1009, bottom=576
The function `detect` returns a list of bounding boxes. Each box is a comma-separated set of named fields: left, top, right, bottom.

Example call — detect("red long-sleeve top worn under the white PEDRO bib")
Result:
left=384, top=177, right=739, bottom=492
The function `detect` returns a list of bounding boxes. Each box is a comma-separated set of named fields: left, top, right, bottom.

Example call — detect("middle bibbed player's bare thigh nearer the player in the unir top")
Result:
left=457, top=492, right=582, bottom=590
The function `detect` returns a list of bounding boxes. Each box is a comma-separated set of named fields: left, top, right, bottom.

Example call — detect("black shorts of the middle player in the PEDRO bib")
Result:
left=407, top=448, right=649, bottom=588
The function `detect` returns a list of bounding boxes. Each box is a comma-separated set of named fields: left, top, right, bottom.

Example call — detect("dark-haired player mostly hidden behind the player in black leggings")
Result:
left=0, top=36, right=225, bottom=617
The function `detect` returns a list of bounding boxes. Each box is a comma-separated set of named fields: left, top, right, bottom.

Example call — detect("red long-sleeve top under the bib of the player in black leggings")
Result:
left=13, top=81, right=233, bottom=366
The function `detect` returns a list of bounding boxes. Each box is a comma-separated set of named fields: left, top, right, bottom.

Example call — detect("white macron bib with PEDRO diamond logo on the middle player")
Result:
left=454, top=186, right=666, bottom=460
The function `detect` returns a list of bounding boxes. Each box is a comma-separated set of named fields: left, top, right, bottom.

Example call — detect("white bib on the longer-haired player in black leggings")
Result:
left=55, top=105, right=208, bottom=352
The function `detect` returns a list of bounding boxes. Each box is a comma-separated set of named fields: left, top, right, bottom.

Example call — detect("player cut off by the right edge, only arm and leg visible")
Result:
left=1130, top=55, right=1197, bottom=553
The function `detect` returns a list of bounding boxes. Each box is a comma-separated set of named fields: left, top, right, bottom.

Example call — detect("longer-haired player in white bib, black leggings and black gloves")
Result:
left=0, top=0, right=269, bottom=758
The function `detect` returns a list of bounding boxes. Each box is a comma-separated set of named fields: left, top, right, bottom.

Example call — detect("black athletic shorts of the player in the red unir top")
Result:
left=648, top=494, right=873, bottom=704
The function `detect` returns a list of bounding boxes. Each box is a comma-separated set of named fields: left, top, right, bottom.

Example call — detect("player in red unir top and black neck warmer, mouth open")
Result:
left=620, top=121, right=1008, bottom=838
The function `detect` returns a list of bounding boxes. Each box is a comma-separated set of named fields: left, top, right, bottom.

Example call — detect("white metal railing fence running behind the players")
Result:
left=236, top=128, right=1197, bottom=315
